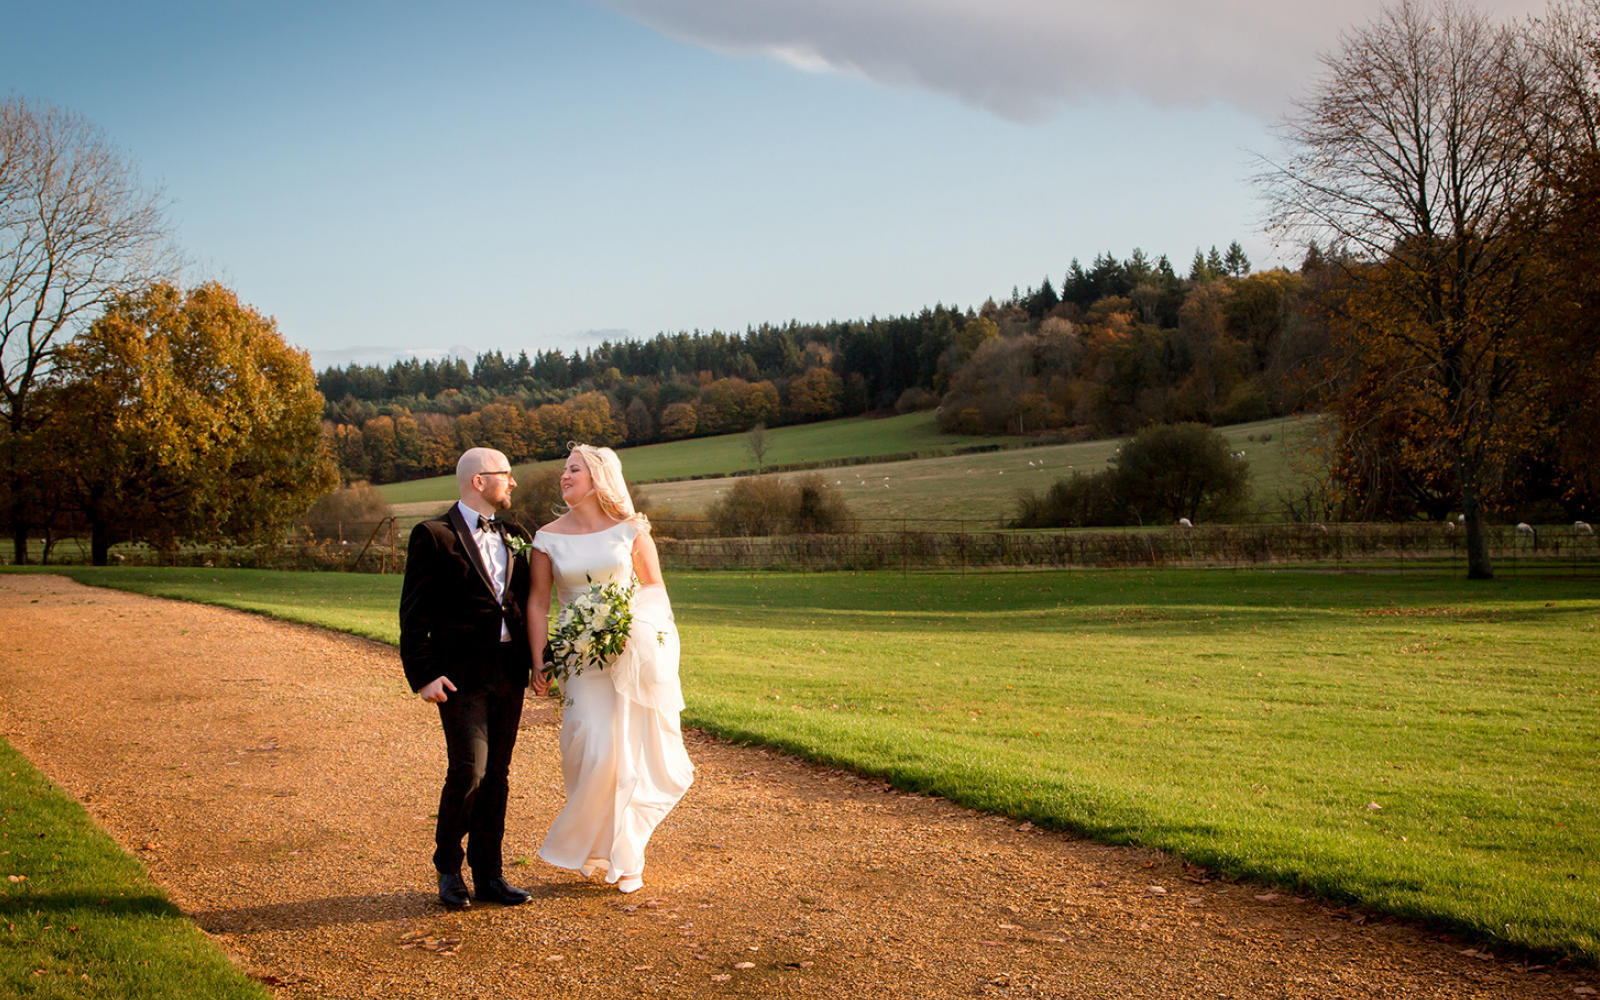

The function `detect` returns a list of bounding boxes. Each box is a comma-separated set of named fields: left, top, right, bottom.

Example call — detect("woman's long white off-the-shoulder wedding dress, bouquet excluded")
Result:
left=533, top=522, right=694, bottom=885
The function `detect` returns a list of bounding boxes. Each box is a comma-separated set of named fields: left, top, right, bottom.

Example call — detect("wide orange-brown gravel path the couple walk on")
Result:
left=0, top=574, right=1580, bottom=1000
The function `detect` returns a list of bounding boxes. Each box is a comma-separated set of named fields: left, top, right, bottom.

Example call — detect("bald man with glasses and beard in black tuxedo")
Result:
left=400, top=448, right=533, bottom=909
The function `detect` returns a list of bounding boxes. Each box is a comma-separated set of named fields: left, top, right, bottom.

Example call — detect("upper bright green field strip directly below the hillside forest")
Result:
left=378, top=413, right=1016, bottom=504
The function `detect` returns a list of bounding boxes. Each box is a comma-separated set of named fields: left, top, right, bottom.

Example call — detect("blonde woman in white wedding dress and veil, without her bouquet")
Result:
left=528, top=445, right=694, bottom=893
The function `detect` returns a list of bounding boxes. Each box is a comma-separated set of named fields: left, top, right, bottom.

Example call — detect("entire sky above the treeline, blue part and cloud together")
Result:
left=0, top=0, right=1534, bottom=368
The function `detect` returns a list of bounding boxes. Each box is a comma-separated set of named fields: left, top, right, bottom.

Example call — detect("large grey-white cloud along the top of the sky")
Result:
left=602, top=0, right=1544, bottom=120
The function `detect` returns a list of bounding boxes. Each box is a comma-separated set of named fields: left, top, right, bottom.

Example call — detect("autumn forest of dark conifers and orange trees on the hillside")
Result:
left=317, top=243, right=1325, bottom=483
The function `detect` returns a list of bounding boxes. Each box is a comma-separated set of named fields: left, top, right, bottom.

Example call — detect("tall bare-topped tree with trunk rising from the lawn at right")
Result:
left=1264, top=0, right=1541, bottom=579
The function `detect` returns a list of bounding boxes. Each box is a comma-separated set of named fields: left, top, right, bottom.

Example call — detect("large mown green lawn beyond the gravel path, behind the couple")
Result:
left=28, top=570, right=1600, bottom=963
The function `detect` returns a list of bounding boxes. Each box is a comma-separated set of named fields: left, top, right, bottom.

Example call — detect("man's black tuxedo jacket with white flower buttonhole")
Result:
left=400, top=504, right=533, bottom=691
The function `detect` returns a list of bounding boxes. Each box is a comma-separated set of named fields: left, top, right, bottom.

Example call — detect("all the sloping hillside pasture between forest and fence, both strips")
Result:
left=379, top=413, right=1317, bottom=530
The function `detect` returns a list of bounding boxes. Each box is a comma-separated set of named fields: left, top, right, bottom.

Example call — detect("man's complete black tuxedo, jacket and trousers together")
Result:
left=400, top=504, right=533, bottom=883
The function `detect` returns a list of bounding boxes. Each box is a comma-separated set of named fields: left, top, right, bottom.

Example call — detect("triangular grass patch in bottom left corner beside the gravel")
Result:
left=0, top=739, right=270, bottom=1000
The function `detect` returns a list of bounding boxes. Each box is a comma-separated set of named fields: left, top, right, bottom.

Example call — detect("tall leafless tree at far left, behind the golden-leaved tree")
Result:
left=0, top=98, right=171, bottom=563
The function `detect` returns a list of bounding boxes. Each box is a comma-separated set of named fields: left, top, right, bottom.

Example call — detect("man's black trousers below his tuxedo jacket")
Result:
left=434, top=643, right=526, bottom=883
